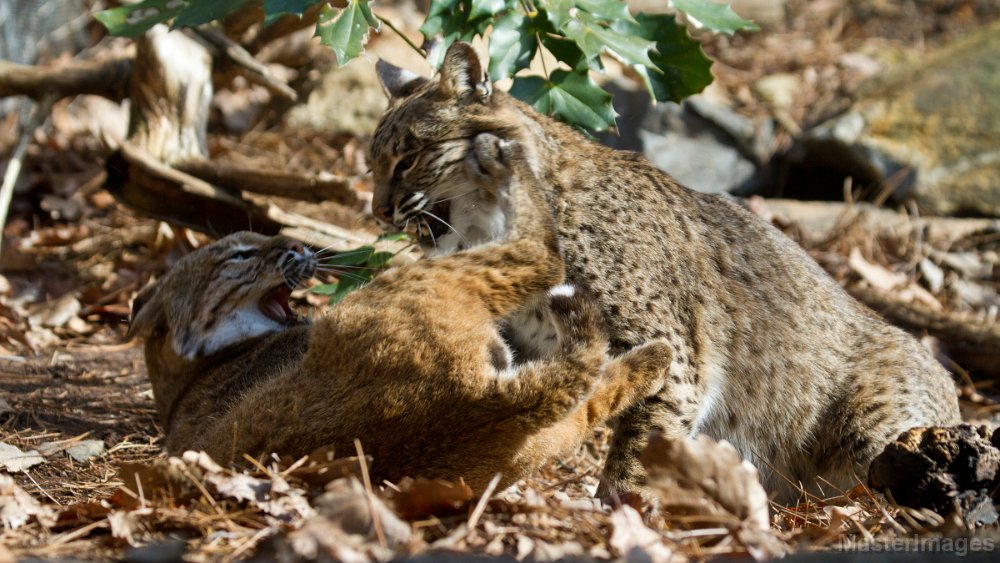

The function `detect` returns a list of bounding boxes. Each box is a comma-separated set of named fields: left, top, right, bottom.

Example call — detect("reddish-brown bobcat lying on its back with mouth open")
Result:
left=129, top=136, right=670, bottom=490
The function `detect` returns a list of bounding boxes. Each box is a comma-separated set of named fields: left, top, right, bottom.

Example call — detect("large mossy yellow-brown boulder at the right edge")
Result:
left=786, top=22, right=1000, bottom=216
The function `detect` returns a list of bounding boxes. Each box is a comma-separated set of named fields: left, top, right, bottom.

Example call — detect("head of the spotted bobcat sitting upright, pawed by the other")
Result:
left=369, top=48, right=515, bottom=255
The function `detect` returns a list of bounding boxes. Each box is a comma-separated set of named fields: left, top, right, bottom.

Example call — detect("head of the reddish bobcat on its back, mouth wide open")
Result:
left=129, top=232, right=316, bottom=359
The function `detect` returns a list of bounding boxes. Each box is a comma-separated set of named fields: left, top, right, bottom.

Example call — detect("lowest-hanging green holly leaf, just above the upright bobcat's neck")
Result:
left=510, top=69, right=617, bottom=131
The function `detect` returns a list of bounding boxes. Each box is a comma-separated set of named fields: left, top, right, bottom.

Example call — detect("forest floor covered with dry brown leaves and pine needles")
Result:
left=0, top=0, right=1000, bottom=562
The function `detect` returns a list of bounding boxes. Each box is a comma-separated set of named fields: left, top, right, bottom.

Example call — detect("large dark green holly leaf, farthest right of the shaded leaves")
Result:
left=614, top=14, right=712, bottom=102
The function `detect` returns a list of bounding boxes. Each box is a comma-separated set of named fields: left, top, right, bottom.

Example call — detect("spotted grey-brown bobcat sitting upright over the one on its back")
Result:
left=369, top=42, right=958, bottom=501
